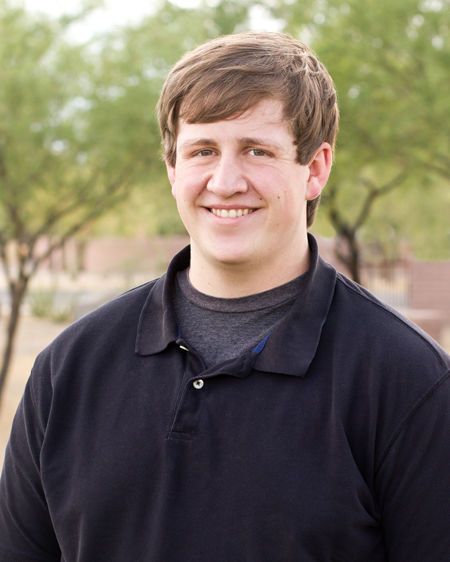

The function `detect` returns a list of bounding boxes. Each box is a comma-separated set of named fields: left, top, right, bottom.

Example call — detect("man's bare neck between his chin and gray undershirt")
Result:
left=189, top=246, right=309, bottom=298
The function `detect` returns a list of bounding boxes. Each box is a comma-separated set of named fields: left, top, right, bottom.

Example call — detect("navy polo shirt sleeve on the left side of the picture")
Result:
left=0, top=350, right=61, bottom=562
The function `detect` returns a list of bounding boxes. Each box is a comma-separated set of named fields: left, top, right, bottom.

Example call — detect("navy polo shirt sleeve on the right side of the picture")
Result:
left=377, top=373, right=450, bottom=562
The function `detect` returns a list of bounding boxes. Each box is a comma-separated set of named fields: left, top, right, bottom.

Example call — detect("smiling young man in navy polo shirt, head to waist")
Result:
left=0, top=33, right=450, bottom=562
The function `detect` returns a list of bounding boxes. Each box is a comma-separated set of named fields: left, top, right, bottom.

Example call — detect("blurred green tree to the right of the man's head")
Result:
left=271, top=0, right=450, bottom=280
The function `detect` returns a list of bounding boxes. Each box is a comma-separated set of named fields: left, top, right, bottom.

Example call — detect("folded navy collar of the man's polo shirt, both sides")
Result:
left=136, top=234, right=336, bottom=376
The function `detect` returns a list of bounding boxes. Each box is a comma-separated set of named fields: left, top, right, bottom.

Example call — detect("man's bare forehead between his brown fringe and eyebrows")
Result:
left=177, top=99, right=293, bottom=144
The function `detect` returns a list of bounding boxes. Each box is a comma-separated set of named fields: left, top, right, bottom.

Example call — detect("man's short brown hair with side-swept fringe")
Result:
left=157, top=32, right=339, bottom=226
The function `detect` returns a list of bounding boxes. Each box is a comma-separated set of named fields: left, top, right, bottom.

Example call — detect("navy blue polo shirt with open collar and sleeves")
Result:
left=0, top=234, right=450, bottom=562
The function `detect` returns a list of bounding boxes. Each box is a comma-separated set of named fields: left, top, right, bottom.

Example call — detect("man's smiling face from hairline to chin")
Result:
left=168, top=99, right=328, bottom=280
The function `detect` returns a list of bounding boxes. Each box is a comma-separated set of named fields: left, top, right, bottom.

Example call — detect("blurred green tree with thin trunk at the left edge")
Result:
left=0, top=0, right=157, bottom=396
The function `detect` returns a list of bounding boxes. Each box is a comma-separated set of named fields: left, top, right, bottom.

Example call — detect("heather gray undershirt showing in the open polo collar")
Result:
left=175, top=269, right=303, bottom=367
